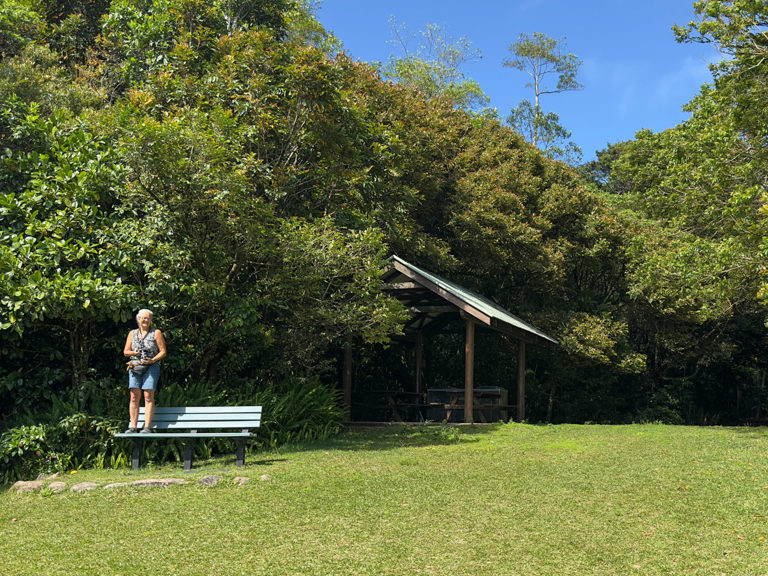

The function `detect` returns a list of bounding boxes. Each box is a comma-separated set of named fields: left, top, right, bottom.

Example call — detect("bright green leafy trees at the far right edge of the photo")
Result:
left=611, top=1, right=768, bottom=424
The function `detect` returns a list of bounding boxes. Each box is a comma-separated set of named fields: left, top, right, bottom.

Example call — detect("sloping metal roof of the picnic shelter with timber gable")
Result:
left=383, top=255, right=558, bottom=346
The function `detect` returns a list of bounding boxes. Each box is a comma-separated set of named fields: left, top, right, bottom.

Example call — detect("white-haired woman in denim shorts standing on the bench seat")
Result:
left=123, top=310, right=166, bottom=433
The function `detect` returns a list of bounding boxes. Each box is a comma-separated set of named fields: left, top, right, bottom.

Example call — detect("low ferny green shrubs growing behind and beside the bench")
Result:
left=0, top=377, right=343, bottom=483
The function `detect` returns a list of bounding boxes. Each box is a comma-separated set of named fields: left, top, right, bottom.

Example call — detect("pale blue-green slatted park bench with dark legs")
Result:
left=115, top=406, right=261, bottom=470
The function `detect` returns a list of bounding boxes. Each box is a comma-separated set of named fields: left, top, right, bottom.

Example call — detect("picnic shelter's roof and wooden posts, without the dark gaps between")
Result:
left=343, top=255, right=558, bottom=422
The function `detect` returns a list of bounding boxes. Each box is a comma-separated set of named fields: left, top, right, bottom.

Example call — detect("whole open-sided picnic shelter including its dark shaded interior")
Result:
left=341, top=256, right=557, bottom=422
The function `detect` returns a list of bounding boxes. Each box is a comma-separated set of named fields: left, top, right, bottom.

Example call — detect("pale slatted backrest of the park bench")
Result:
left=138, top=406, right=261, bottom=430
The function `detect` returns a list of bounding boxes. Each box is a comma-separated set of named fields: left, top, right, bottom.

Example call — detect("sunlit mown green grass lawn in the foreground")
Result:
left=0, top=424, right=768, bottom=576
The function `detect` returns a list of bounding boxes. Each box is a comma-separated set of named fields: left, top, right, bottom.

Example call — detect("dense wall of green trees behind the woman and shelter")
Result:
left=0, top=0, right=768, bottom=434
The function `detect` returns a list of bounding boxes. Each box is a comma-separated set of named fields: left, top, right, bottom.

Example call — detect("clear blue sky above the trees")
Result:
left=317, top=0, right=718, bottom=161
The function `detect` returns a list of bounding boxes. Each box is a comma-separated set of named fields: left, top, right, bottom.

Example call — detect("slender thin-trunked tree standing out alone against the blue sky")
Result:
left=504, top=32, right=583, bottom=163
